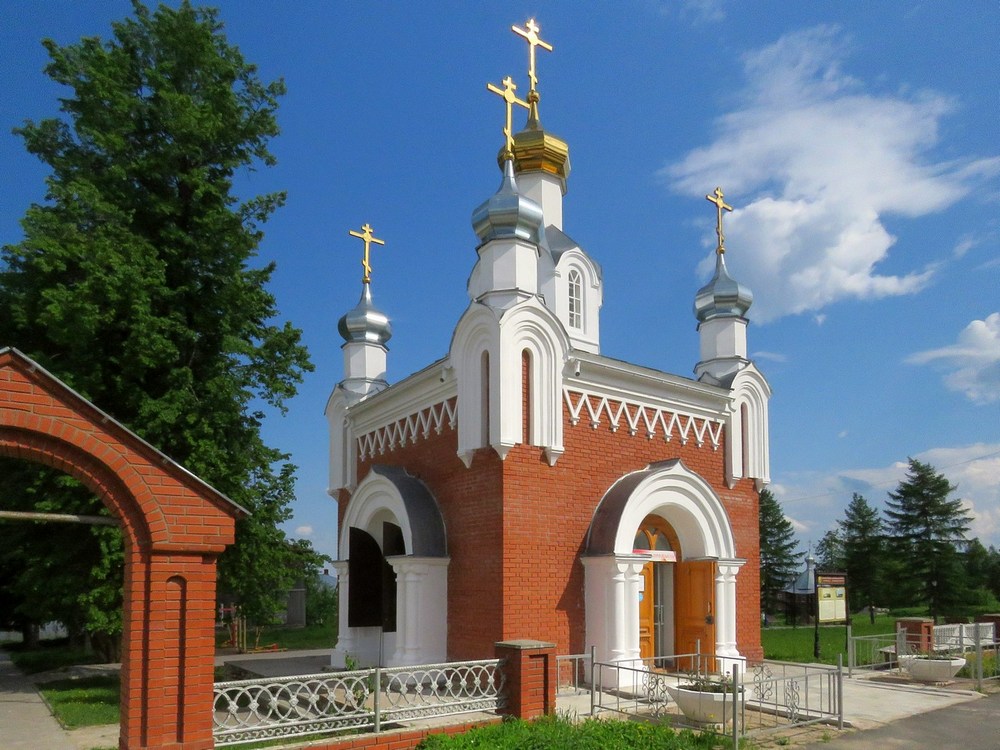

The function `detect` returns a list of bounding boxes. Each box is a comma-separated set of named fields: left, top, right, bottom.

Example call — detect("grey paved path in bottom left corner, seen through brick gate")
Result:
left=0, top=649, right=76, bottom=750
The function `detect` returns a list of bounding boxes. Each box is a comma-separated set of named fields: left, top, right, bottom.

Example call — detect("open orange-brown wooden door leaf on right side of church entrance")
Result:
left=674, top=560, right=715, bottom=670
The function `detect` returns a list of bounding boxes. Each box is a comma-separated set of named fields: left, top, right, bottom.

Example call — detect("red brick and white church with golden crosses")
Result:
left=326, top=20, right=770, bottom=667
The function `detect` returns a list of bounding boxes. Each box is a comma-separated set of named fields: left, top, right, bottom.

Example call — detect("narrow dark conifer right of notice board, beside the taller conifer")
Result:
left=838, top=492, right=885, bottom=623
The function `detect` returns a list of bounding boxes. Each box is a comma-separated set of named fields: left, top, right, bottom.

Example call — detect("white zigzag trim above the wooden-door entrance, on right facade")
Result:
left=563, top=388, right=725, bottom=450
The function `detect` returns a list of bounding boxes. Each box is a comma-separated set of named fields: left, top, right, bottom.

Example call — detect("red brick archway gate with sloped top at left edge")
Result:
left=0, top=349, right=246, bottom=750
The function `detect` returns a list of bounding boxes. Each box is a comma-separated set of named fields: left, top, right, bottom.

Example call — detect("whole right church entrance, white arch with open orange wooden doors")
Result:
left=583, top=460, right=744, bottom=672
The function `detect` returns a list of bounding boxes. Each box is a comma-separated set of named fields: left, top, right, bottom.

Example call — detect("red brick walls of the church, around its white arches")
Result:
left=348, top=388, right=762, bottom=659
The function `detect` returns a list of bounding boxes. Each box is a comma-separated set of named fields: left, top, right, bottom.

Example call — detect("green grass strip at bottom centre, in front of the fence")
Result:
left=417, top=717, right=719, bottom=750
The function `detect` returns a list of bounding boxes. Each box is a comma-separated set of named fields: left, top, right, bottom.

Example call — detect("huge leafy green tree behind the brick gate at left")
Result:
left=0, top=0, right=311, bottom=648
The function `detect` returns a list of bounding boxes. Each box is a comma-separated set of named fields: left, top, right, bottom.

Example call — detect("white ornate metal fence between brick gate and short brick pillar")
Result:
left=213, top=659, right=504, bottom=747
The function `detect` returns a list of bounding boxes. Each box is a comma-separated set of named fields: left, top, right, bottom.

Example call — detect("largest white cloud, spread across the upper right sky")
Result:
left=662, top=26, right=1000, bottom=323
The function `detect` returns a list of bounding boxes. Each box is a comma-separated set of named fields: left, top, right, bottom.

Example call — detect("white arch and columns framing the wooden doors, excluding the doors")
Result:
left=583, top=460, right=745, bottom=672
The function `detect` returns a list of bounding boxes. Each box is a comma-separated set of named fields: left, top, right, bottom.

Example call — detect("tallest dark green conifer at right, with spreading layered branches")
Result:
left=885, top=458, right=971, bottom=621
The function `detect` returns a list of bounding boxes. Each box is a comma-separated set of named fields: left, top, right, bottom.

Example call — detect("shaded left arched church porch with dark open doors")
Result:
left=332, top=465, right=449, bottom=667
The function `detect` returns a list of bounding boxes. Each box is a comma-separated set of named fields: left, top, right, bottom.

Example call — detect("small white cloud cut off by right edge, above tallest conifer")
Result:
left=906, top=312, right=1000, bottom=404
